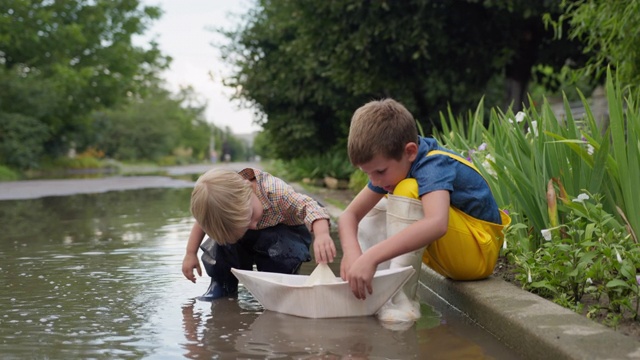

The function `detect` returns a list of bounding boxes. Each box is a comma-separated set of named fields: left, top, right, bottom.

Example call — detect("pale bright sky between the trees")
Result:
left=135, top=0, right=260, bottom=134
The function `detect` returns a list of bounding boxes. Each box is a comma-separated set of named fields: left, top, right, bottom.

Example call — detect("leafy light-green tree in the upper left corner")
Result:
left=0, top=0, right=170, bottom=166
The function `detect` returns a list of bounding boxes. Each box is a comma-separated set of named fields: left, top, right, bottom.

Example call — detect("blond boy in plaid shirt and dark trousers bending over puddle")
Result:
left=182, top=168, right=336, bottom=300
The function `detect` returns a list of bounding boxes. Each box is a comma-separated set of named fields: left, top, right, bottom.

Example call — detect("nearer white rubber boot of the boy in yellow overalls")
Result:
left=378, top=195, right=426, bottom=322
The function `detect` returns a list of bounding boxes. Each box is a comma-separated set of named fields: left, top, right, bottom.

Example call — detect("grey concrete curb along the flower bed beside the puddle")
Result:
left=302, top=184, right=640, bottom=359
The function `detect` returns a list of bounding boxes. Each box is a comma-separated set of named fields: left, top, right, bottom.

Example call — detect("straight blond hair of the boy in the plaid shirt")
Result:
left=191, top=169, right=253, bottom=245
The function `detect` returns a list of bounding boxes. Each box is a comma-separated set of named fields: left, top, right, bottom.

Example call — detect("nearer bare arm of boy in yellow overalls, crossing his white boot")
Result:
left=341, top=190, right=450, bottom=299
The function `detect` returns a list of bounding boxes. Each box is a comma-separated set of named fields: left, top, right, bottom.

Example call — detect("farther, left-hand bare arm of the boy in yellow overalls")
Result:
left=338, top=187, right=384, bottom=280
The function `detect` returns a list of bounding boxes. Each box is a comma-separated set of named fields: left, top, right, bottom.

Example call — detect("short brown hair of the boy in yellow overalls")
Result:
left=347, top=98, right=418, bottom=166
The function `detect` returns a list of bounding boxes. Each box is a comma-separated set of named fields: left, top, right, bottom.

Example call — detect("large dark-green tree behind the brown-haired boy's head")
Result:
left=223, top=0, right=592, bottom=159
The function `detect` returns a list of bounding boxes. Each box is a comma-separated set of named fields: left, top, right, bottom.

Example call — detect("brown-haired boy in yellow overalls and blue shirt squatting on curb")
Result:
left=338, top=99, right=510, bottom=321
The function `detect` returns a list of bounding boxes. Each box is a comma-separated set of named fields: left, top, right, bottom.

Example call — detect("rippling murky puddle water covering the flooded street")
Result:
left=0, top=189, right=513, bottom=359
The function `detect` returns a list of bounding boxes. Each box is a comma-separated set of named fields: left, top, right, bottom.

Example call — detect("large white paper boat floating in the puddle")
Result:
left=231, top=266, right=415, bottom=319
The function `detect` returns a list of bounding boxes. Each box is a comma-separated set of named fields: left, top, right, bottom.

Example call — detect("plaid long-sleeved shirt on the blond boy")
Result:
left=238, top=168, right=330, bottom=231
